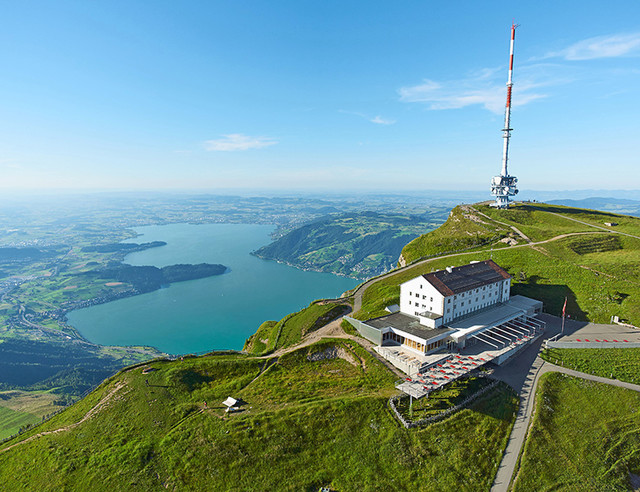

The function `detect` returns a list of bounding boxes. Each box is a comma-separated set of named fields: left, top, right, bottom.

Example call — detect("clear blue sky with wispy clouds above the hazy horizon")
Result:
left=0, top=0, right=640, bottom=194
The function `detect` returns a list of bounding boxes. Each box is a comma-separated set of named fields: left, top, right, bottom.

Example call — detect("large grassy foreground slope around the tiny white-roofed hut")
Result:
left=0, top=340, right=515, bottom=491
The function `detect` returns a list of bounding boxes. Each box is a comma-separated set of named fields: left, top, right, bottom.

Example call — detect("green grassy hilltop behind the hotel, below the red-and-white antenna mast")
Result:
left=355, top=204, right=640, bottom=325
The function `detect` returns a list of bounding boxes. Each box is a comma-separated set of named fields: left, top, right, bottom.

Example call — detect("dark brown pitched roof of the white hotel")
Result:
left=423, top=260, right=511, bottom=296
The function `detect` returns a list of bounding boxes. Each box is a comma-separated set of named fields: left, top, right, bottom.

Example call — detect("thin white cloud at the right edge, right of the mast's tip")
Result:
left=545, top=33, right=640, bottom=60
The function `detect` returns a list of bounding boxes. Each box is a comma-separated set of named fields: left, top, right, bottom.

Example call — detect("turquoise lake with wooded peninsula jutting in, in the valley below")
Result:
left=67, top=224, right=359, bottom=354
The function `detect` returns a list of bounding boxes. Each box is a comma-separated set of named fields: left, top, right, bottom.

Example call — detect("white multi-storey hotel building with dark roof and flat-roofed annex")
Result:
left=348, top=260, right=544, bottom=364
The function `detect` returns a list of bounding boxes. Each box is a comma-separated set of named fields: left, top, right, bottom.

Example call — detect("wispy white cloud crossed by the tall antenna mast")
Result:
left=398, top=75, right=546, bottom=114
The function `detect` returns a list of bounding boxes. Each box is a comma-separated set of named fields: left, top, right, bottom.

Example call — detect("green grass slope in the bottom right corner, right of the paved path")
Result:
left=513, top=373, right=640, bottom=492
